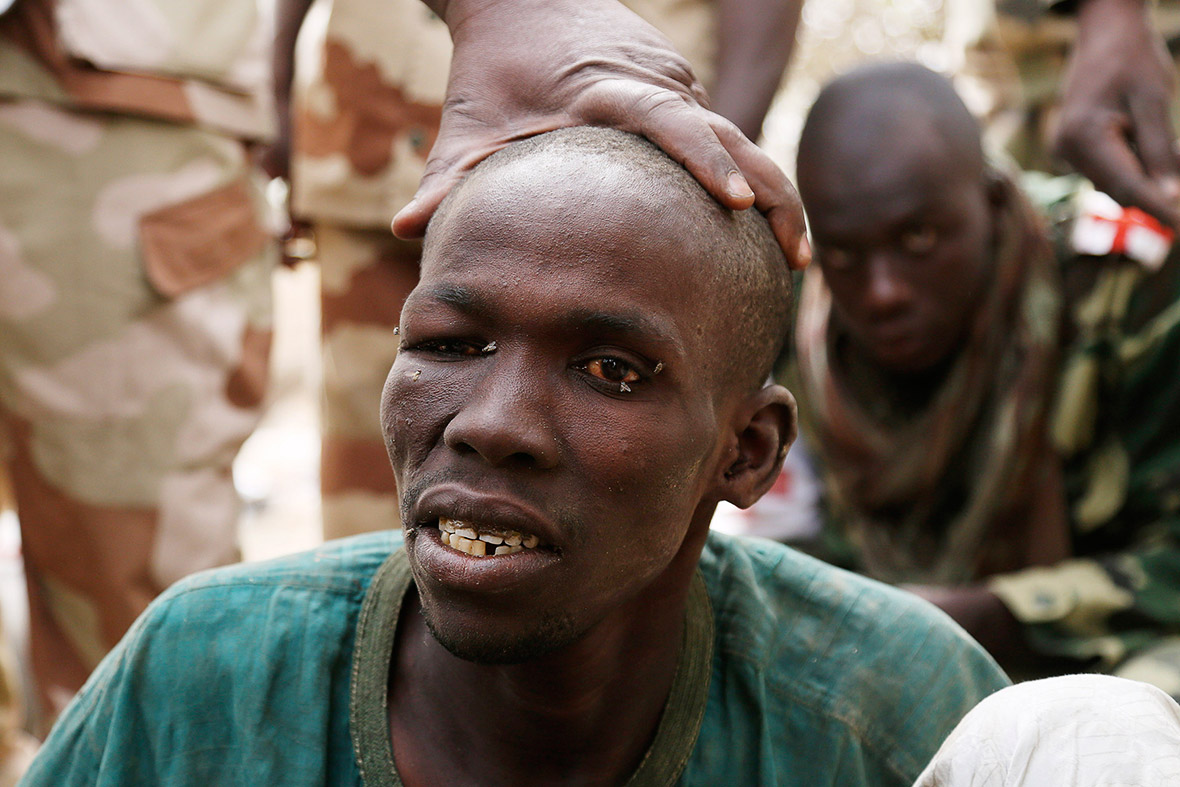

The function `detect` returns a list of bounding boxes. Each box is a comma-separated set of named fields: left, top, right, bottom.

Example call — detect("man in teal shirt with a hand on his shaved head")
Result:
left=23, top=129, right=1005, bottom=787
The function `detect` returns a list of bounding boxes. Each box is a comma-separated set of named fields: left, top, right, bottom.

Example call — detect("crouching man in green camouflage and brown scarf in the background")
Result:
left=795, top=64, right=1180, bottom=694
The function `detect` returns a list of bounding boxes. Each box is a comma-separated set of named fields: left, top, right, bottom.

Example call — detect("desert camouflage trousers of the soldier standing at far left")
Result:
left=0, top=101, right=274, bottom=719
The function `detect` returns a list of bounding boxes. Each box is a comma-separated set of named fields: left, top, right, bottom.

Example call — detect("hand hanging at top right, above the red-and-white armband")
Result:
left=1056, top=0, right=1180, bottom=229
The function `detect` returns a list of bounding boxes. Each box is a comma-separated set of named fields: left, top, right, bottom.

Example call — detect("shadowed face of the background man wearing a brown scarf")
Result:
left=799, top=90, right=997, bottom=382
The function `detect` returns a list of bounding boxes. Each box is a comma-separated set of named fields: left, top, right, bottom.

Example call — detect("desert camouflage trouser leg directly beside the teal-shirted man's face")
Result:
left=315, top=224, right=421, bottom=538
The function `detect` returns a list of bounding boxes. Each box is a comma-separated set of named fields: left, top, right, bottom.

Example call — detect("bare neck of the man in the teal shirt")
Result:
left=389, top=519, right=703, bottom=787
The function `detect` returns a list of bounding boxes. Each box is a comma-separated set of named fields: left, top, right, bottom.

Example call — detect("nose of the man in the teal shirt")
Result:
left=443, top=349, right=558, bottom=470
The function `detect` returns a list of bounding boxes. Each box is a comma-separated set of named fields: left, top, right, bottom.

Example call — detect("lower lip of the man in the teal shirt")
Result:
left=411, top=527, right=561, bottom=593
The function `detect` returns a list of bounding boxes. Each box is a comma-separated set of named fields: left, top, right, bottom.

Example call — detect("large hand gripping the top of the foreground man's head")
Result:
left=393, top=0, right=809, bottom=268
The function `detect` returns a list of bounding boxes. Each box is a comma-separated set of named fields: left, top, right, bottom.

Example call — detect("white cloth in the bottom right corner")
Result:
left=915, top=675, right=1180, bottom=787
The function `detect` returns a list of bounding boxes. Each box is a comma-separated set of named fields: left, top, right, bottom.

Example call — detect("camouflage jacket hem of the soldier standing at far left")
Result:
left=0, top=0, right=274, bottom=139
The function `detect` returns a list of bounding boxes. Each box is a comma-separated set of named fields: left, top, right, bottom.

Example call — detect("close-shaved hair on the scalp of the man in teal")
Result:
left=424, top=126, right=791, bottom=392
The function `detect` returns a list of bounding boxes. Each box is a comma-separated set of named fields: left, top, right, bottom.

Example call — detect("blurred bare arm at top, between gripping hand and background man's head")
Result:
left=712, top=0, right=804, bottom=139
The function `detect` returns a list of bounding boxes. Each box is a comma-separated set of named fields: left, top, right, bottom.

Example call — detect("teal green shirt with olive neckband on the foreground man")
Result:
left=22, top=532, right=1007, bottom=787
